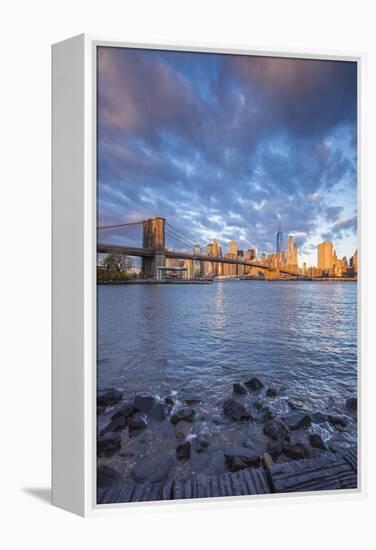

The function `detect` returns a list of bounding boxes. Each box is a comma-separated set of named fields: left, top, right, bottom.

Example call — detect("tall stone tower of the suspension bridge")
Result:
left=141, top=217, right=166, bottom=279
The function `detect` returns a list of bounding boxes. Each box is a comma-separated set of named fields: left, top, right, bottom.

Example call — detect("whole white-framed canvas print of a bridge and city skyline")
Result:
left=52, top=35, right=364, bottom=515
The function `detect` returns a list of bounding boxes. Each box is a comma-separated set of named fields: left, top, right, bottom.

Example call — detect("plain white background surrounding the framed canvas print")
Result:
left=0, top=0, right=376, bottom=550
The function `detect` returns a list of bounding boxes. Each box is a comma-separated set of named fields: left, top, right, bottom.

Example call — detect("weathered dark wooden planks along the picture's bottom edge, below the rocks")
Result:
left=97, top=450, right=357, bottom=504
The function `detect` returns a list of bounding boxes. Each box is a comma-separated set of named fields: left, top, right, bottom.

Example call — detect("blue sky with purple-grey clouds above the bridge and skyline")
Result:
left=97, top=47, right=357, bottom=265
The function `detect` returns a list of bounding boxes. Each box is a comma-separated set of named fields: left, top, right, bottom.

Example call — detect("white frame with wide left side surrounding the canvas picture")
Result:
left=52, top=34, right=366, bottom=516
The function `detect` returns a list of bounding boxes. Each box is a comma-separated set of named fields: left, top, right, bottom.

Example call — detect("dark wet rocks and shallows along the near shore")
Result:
left=97, top=376, right=358, bottom=504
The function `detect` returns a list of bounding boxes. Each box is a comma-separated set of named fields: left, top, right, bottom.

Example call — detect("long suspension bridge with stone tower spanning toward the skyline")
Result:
left=97, top=217, right=306, bottom=279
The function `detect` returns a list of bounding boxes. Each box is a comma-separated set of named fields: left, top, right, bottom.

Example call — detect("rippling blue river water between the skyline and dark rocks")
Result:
left=97, top=281, right=357, bottom=486
